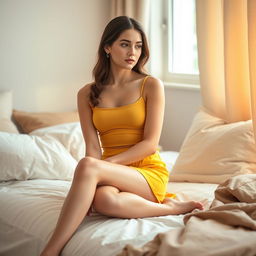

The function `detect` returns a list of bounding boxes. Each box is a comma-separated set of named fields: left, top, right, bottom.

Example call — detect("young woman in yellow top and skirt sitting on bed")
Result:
left=41, top=16, right=203, bottom=256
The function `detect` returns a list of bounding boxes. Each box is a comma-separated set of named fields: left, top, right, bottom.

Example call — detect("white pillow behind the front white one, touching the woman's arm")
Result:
left=30, top=122, right=85, bottom=161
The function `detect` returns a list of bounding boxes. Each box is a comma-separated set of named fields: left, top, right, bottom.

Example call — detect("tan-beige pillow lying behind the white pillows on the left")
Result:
left=13, top=110, right=79, bottom=133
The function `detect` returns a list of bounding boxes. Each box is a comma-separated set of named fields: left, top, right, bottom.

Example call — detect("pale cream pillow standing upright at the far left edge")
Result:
left=0, top=91, right=18, bottom=133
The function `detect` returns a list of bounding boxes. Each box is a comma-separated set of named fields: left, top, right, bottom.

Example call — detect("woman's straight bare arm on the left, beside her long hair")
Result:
left=77, top=84, right=102, bottom=159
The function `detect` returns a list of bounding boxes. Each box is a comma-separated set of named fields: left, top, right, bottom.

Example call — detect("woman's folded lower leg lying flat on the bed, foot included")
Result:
left=93, top=186, right=203, bottom=218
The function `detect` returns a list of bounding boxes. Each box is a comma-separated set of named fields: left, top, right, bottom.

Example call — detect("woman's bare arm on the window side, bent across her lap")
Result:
left=105, top=77, right=165, bottom=165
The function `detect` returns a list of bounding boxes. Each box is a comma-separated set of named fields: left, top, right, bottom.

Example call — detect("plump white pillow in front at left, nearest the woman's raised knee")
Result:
left=0, top=132, right=77, bottom=181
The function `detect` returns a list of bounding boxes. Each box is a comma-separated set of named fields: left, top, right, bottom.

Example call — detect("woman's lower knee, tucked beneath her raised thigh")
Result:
left=93, top=187, right=119, bottom=215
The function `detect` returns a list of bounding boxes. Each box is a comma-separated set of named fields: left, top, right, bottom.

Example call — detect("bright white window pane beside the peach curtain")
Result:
left=168, top=0, right=199, bottom=75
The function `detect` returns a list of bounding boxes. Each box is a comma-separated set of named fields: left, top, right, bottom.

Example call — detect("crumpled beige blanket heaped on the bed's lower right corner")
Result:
left=118, top=174, right=256, bottom=256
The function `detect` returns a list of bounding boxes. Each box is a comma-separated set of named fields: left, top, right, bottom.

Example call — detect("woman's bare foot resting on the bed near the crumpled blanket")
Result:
left=163, top=198, right=204, bottom=215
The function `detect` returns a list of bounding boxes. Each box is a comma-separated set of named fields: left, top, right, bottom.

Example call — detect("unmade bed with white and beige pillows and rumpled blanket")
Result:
left=0, top=91, right=256, bottom=256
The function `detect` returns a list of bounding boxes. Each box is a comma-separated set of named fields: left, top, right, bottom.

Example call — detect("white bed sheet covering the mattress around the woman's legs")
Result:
left=0, top=180, right=217, bottom=256
